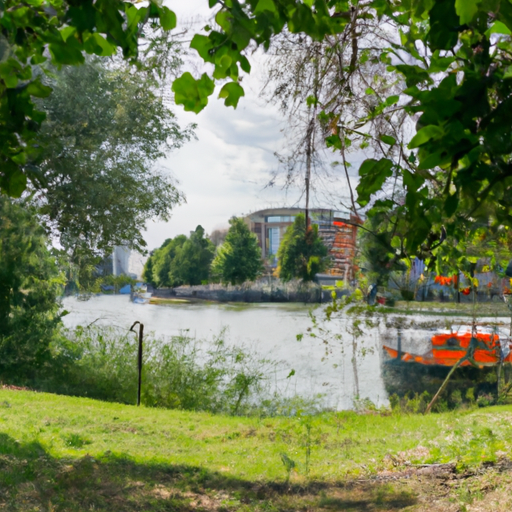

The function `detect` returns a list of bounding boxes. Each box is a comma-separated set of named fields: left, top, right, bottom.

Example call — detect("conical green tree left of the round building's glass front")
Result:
left=212, top=217, right=263, bottom=284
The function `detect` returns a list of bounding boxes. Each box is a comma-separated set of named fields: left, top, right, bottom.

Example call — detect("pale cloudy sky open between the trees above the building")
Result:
left=144, top=0, right=358, bottom=250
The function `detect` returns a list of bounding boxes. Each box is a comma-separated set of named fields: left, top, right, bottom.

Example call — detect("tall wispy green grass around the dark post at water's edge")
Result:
left=47, top=326, right=284, bottom=414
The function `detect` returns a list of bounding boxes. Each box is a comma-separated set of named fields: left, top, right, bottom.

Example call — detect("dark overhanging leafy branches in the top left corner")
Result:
left=0, top=0, right=176, bottom=197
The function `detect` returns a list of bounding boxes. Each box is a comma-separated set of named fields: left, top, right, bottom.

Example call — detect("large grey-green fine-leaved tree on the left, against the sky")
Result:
left=37, top=59, right=192, bottom=262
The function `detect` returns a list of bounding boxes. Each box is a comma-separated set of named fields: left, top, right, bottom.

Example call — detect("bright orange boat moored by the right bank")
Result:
left=383, top=332, right=512, bottom=368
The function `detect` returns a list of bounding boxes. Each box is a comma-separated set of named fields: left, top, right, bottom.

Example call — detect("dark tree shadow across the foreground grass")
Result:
left=0, top=434, right=416, bottom=512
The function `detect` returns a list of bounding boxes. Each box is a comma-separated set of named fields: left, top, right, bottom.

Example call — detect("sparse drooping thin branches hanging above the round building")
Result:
left=262, top=19, right=406, bottom=213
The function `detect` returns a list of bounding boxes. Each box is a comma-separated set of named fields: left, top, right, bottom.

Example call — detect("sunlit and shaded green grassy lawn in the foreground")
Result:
left=0, top=389, right=512, bottom=512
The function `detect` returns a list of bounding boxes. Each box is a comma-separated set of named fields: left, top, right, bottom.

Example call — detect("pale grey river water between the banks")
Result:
left=63, top=295, right=387, bottom=410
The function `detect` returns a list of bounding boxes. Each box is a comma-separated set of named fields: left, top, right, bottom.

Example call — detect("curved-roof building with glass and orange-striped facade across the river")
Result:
left=245, top=208, right=360, bottom=280
